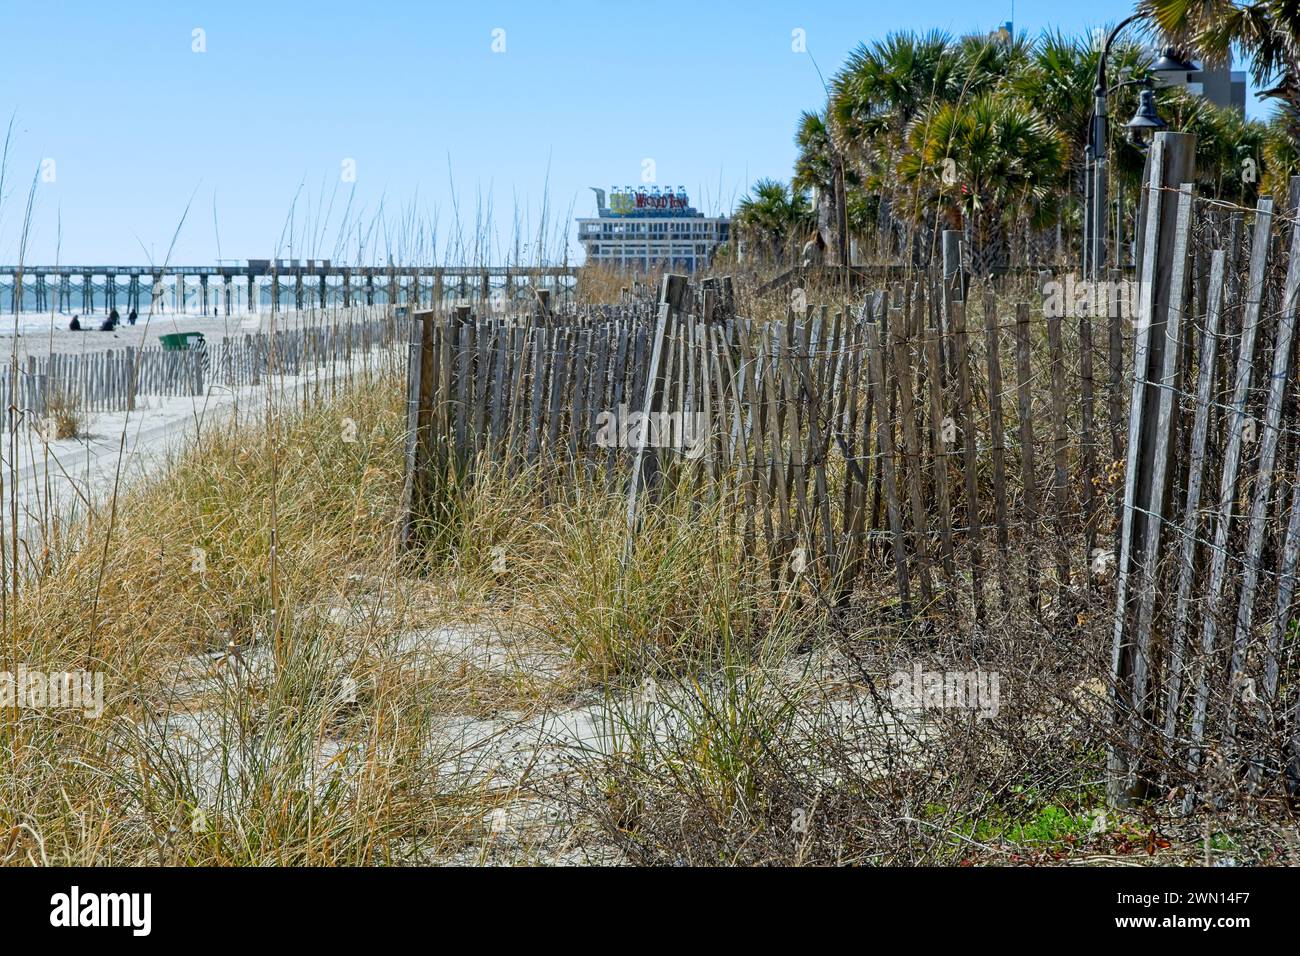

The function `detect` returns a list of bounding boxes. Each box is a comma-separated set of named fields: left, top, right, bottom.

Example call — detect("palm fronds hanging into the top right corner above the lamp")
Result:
left=1139, top=0, right=1300, bottom=143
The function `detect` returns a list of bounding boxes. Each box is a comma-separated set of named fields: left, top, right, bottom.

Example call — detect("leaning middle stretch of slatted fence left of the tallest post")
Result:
left=406, top=276, right=1125, bottom=620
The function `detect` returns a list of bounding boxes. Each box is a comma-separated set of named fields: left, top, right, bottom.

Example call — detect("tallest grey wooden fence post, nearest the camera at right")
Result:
left=1106, top=133, right=1196, bottom=806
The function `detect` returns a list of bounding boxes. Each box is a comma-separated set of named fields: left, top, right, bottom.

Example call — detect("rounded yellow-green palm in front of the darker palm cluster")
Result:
left=898, top=92, right=1066, bottom=273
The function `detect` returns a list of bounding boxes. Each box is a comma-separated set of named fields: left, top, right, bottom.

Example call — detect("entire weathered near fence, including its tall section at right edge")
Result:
left=406, top=134, right=1300, bottom=803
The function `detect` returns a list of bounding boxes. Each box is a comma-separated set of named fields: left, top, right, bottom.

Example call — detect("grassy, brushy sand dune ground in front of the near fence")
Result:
left=0, top=282, right=1279, bottom=865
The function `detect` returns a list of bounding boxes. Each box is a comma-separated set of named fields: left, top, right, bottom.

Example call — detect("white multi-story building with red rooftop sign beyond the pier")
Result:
left=577, top=186, right=731, bottom=272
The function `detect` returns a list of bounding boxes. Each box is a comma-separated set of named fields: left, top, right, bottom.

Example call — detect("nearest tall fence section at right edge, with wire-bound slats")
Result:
left=1110, top=134, right=1300, bottom=808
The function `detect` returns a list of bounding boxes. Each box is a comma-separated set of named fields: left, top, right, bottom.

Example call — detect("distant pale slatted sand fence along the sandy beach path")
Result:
left=0, top=310, right=407, bottom=429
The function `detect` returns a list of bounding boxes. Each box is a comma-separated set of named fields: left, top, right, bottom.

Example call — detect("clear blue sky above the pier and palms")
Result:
left=0, top=0, right=1260, bottom=264
